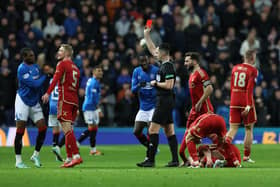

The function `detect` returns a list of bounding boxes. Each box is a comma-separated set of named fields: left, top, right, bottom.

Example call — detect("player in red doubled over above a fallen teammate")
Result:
left=185, top=113, right=240, bottom=167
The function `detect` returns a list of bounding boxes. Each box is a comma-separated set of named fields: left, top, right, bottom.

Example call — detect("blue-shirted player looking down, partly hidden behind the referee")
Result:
left=131, top=54, right=158, bottom=161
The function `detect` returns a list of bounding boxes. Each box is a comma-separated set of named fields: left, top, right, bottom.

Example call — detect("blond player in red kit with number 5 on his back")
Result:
left=42, top=44, right=83, bottom=168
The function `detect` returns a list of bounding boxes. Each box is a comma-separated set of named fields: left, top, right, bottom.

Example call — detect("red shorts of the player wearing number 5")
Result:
left=57, top=101, right=78, bottom=123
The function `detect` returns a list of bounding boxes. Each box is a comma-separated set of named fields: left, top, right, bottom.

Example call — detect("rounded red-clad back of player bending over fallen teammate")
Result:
left=190, top=114, right=227, bottom=138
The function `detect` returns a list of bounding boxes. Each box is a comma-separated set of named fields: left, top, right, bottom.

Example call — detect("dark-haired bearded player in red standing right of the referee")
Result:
left=179, top=52, right=214, bottom=166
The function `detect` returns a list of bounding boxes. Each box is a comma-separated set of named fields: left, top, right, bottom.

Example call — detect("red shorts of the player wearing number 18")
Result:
left=229, top=107, right=257, bottom=125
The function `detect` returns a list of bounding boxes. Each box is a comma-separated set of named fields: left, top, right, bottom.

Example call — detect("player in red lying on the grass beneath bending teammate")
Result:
left=197, top=144, right=241, bottom=168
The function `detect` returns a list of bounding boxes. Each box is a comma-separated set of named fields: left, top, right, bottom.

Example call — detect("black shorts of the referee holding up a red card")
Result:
left=152, top=95, right=175, bottom=126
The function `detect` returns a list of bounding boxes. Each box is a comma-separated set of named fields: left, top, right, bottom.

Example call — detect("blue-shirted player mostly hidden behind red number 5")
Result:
left=48, top=79, right=63, bottom=162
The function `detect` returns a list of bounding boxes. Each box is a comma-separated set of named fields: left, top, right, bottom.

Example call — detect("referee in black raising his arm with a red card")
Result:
left=137, top=25, right=179, bottom=167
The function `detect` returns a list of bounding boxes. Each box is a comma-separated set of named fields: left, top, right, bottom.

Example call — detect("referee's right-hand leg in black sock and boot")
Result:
left=164, top=123, right=179, bottom=167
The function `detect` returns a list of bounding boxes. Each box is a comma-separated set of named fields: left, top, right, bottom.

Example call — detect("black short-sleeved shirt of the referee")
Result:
left=156, top=61, right=176, bottom=96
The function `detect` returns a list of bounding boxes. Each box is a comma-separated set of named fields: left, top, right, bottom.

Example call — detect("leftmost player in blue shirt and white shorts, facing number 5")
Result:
left=14, top=48, right=47, bottom=168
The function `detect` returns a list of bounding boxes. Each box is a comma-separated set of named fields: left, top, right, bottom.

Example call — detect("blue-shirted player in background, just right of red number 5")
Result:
left=78, top=65, right=103, bottom=156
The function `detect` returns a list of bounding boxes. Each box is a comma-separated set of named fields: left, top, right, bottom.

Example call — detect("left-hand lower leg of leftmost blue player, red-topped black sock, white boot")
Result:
left=14, top=121, right=29, bottom=169
